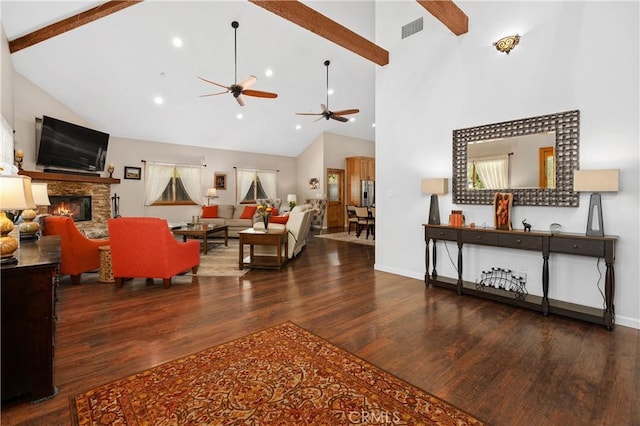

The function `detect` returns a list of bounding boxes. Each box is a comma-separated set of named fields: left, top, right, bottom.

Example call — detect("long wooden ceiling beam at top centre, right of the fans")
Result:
left=249, top=0, right=389, bottom=66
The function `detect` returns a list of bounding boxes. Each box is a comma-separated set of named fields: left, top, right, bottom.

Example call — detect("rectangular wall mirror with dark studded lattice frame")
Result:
left=452, top=110, right=580, bottom=207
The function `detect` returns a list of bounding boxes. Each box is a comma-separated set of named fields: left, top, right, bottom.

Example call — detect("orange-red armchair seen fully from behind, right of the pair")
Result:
left=108, top=217, right=200, bottom=288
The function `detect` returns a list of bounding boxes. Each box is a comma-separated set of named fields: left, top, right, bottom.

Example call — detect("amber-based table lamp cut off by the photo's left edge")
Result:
left=0, top=175, right=36, bottom=264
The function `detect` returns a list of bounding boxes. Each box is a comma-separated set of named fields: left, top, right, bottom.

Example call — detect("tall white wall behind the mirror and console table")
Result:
left=376, top=1, right=640, bottom=328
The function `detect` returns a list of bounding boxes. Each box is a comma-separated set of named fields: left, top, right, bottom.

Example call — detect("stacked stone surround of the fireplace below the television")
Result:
left=33, top=179, right=111, bottom=232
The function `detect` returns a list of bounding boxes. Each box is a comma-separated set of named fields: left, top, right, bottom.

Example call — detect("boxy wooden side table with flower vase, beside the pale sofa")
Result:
left=238, top=228, right=289, bottom=269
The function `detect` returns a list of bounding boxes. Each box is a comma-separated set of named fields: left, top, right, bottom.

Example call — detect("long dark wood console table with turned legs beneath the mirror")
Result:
left=423, top=224, right=618, bottom=330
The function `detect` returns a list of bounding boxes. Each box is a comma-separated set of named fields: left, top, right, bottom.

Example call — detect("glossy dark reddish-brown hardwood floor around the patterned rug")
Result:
left=1, top=231, right=640, bottom=425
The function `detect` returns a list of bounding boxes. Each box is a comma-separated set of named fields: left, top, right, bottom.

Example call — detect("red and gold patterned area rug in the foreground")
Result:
left=70, top=322, right=483, bottom=425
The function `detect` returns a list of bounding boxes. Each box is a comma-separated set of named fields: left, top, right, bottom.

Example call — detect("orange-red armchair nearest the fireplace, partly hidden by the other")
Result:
left=42, top=216, right=109, bottom=284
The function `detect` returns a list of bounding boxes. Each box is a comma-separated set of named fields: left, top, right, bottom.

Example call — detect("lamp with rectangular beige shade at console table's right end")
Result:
left=573, top=169, right=619, bottom=237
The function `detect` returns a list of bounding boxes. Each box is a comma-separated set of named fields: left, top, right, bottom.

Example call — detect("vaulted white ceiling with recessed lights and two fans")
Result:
left=0, top=0, right=380, bottom=156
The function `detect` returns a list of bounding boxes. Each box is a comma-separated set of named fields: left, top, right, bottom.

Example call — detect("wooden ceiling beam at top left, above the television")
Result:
left=9, top=0, right=143, bottom=53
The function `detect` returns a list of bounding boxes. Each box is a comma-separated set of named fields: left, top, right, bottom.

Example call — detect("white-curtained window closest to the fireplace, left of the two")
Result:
left=145, top=163, right=202, bottom=206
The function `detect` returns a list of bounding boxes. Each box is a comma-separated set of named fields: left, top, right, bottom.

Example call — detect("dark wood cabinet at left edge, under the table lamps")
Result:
left=0, top=236, right=60, bottom=403
